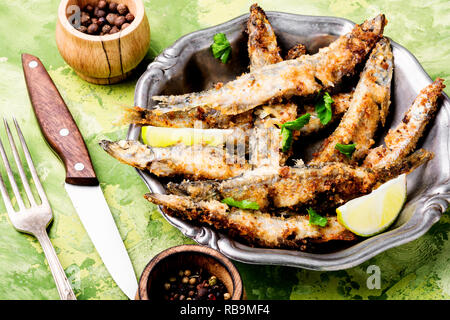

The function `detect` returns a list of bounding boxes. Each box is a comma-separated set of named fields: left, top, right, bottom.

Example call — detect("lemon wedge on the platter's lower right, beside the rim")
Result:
left=336, top=174, right=406, bottom=237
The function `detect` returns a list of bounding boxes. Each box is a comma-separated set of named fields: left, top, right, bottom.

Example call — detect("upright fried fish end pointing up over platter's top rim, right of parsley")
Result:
left=247, top=4, right=283, bottom=71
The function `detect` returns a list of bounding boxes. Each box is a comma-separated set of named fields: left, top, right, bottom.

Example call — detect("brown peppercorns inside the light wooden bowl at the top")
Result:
left=75, top=0, right=134, bottom=35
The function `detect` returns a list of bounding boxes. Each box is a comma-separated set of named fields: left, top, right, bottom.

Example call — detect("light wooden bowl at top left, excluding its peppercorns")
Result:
left=56, top=0, right=150, bottom=84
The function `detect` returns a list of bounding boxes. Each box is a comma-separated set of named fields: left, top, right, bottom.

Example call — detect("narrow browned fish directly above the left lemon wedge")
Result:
left=121, top=107, right=253, bottom=130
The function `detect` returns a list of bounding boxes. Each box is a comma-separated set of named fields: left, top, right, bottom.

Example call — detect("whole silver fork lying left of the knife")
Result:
left=0, top=118, right=76, bottom=300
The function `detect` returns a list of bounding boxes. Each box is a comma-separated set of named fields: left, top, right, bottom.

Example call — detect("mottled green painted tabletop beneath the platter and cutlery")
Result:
left=0, top=0, right=450, bottom=299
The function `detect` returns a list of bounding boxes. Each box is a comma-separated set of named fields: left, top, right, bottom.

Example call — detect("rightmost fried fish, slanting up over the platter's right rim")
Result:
left=363, top=78, right=445, bottom=168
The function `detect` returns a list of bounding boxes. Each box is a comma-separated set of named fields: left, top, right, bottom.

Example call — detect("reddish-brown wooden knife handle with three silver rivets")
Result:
left=22, top=54, right=98, bottom=185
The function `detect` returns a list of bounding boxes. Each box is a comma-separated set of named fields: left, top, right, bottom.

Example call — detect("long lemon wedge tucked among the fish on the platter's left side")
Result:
left=141, top=126, right=232, bottom=148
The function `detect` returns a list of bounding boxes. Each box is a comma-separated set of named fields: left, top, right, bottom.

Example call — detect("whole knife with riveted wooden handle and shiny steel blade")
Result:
left=22, top=54, right=138, bottom=299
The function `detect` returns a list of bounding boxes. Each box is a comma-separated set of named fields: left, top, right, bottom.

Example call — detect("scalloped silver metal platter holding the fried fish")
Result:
left=127, top=12, right=450, bottom=270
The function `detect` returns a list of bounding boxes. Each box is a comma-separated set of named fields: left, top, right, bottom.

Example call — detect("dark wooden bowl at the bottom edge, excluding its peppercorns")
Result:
left=136, top=245, right=244, bottom=300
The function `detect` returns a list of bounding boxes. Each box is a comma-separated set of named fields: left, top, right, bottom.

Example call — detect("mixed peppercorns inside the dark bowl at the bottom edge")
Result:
left=163, top=269, right=231, bottom=300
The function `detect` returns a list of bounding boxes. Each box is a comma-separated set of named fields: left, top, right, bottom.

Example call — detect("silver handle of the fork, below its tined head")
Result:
left=35, top=230, right=77, bottom=300
